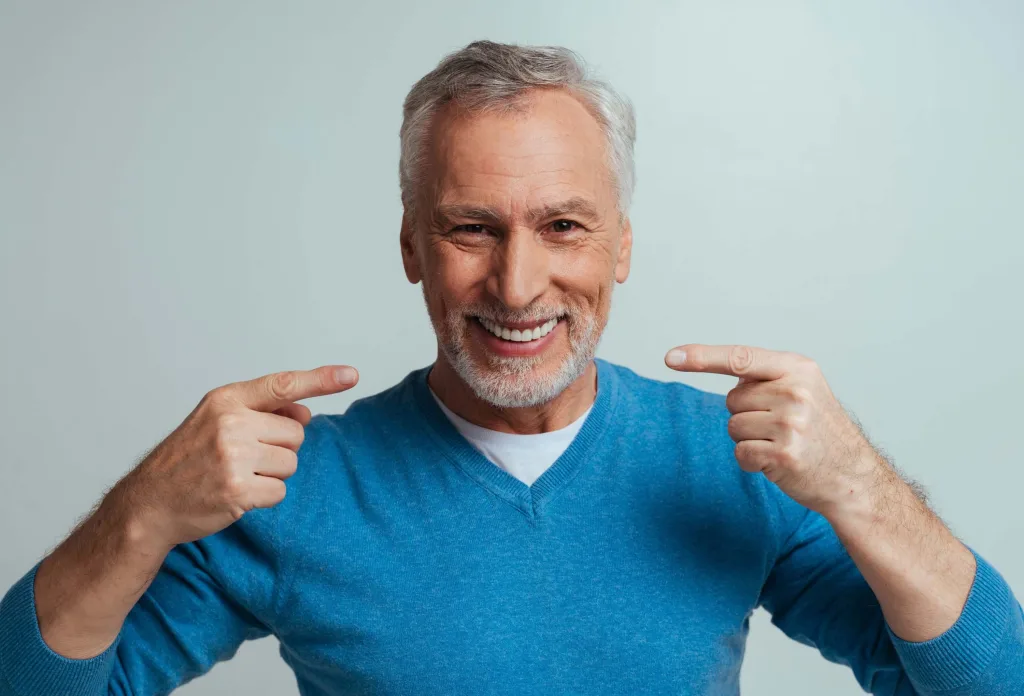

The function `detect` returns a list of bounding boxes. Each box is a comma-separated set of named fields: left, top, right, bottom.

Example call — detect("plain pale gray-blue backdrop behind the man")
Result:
left=0, top=0, right=1024, bottom=696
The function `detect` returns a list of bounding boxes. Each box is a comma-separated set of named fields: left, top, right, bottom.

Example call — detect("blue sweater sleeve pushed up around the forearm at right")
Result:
left=761, top=484, right=1024, bottom=696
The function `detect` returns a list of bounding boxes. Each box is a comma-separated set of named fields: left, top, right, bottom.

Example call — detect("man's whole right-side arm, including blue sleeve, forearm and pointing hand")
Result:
left=666, top=344, right=1024, bottom=696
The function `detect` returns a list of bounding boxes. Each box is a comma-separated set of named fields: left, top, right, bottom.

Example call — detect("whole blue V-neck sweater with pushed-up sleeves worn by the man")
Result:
left=0, top=360, right=1024, bottom=696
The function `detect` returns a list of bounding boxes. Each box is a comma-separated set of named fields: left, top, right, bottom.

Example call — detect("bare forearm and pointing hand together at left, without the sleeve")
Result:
left=20, top=367, right=355, bottom=659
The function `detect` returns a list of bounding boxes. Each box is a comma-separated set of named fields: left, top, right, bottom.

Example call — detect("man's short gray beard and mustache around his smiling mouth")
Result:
left=424, top=287, right=601, bottom=408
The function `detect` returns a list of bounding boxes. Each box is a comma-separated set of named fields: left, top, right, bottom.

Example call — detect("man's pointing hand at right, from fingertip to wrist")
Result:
left=665, top=344, right=888, bottom=516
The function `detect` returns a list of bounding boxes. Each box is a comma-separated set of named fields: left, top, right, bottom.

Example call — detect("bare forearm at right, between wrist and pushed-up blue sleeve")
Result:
left=825, top=454, right=976, bottom=642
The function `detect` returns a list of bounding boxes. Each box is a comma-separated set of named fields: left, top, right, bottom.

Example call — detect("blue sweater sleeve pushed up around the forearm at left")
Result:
left=0, top=518, right=273, bottom=696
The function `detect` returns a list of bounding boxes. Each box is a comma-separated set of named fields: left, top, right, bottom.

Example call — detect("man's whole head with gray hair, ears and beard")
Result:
left=399, top=42, right=635, bottom=407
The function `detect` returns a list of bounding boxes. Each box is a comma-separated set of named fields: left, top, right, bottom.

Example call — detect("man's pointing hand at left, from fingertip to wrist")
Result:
left=118, top=366, right=358, bottom=550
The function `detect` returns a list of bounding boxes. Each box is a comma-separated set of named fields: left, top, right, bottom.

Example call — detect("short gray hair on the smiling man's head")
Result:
left=398, top=41, right=636, bottom=216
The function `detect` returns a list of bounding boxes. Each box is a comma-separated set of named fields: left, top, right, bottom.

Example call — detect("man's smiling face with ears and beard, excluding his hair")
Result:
left=401, top=90, right=632, bottom=407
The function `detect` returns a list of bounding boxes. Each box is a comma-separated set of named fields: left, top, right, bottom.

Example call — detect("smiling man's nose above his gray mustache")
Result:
left=486, top=229, right=550, bottom=310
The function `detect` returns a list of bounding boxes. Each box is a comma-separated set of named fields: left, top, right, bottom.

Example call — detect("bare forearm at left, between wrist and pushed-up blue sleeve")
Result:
left=34, top=482, right=170, bottom=659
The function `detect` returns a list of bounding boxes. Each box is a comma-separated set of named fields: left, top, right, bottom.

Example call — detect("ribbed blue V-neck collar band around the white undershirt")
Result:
left=410, top=358, right=618, bottom=520
